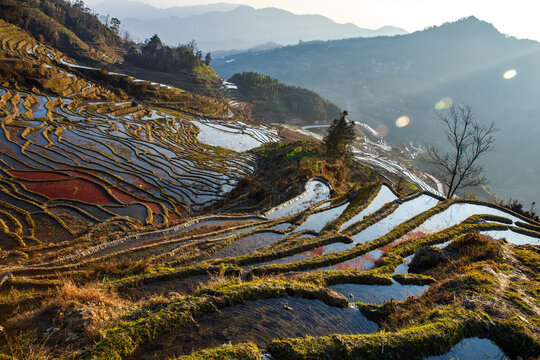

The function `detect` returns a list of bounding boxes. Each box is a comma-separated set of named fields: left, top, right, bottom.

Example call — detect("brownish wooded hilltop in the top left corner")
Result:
left=0, top=0, right=121, bottom=48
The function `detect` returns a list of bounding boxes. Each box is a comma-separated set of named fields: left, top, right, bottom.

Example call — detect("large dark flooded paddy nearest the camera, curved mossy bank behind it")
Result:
left=129, top=297, right=377, bottom=359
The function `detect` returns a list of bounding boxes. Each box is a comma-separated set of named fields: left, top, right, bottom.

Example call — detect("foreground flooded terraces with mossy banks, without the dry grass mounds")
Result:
left=3, top=179, right=540, bottom=359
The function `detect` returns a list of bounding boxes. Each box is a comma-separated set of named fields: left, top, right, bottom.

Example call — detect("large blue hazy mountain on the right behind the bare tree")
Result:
left=213, top=17, right=540, bottom=203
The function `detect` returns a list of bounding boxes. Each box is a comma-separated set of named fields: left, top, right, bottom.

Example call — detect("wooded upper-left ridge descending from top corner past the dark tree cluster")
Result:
left=0, top=0, right=236, bottom=96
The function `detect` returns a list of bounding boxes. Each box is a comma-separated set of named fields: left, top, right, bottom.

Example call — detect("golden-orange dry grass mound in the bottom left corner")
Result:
left=3, top=280, right=132, bottom=359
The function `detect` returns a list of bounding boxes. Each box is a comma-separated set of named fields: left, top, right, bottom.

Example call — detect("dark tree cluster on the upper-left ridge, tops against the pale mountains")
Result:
left=126, top=34, right=212, bottom=73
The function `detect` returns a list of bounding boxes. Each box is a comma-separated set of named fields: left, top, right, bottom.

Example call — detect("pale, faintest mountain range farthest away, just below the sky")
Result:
left=94, top=0, right=406, bottom=51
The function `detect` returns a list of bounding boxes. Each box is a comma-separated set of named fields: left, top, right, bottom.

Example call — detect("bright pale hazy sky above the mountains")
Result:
left=85, top=0, right=540, bottom=41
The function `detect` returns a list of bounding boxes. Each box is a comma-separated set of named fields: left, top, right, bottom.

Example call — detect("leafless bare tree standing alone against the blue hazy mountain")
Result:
left=426, top=105, right=499, bottom=198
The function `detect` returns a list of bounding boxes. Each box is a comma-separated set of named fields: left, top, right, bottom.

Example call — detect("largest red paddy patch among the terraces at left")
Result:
left=21, top=179, right=118, bottom=205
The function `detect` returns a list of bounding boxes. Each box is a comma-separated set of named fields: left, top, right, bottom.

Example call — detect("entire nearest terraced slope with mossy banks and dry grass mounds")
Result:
left=0, top=156, right=540, bottom=360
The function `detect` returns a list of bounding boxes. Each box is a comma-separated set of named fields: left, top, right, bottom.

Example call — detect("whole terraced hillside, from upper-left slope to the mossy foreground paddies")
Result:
left=0, top=9, right=540, bottom=360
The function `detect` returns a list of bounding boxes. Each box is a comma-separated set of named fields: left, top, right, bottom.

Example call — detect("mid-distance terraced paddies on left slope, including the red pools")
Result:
left=0, top=84, right=277, bottom=248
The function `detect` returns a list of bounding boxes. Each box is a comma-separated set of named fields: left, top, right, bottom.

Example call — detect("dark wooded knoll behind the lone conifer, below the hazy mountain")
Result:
left=230, top=72, right=341, bottom=123
